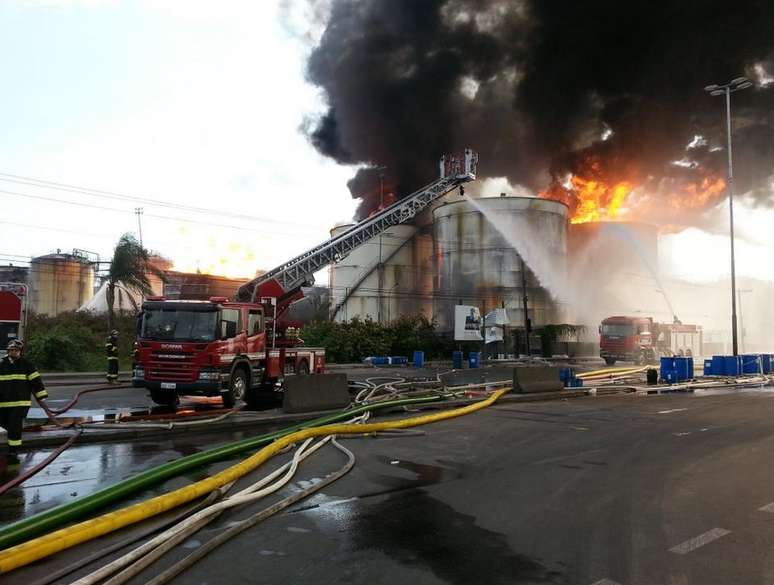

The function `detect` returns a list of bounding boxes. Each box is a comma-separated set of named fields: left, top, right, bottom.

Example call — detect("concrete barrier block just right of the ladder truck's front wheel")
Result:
left=282, top=374, right=350, bottom=413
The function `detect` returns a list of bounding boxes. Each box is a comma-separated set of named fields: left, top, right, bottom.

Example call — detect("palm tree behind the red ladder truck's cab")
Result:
left=105, top=234, right=166, bottom=331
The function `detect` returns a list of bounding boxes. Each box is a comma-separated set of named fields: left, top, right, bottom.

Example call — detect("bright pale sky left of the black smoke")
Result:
left=0, top=0, right=356, bottom=276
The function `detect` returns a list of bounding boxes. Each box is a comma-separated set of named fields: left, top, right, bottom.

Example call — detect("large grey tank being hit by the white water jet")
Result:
left=433, top=196, right=567, bottom=332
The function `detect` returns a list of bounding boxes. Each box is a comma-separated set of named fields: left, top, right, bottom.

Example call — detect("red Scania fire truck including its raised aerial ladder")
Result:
left=132, top=149, right=478, bottom=408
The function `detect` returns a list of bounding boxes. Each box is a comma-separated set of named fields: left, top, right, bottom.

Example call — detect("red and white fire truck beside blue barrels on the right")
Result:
left=599, top=317, right=702, bottom=366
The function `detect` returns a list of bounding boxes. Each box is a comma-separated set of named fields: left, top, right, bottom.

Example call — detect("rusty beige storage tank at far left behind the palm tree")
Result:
left=29, top=253, right=94, bottom=316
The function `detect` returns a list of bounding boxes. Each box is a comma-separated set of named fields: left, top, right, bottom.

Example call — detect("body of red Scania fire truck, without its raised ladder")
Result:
left=132, top=297, right=325, bottom=408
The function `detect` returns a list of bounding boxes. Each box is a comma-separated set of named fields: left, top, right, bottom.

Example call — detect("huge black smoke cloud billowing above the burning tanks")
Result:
left=308, top=0, right=774, bottom=217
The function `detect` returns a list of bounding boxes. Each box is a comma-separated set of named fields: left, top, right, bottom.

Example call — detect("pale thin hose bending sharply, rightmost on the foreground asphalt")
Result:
left=146, top=438, right=355, bottom=585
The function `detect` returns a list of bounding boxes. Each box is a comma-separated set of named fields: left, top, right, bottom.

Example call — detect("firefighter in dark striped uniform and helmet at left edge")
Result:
left=0, top=339, right=48, bottom=462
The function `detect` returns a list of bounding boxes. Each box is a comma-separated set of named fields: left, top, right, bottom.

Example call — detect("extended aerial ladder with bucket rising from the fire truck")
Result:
left=236, top=148, right=478, bottom=318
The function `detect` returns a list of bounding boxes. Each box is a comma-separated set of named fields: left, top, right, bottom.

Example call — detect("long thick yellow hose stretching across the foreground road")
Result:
left=0, top=388, right=509, bottom=573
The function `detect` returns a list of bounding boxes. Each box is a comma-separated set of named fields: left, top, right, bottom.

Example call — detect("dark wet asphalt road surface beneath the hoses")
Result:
left=9, top=391, right=774, bottom=585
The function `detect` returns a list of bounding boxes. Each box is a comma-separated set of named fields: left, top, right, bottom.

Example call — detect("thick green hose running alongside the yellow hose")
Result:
left=0, top=395, right=444, bottom=550
